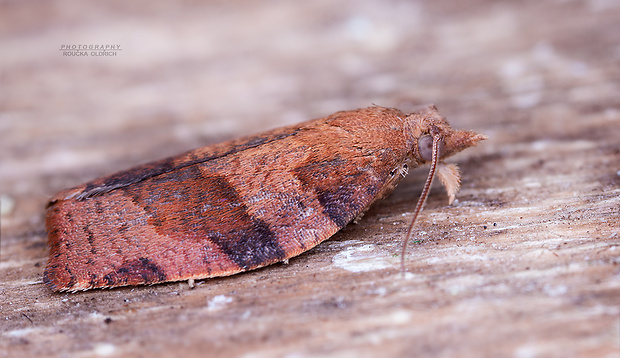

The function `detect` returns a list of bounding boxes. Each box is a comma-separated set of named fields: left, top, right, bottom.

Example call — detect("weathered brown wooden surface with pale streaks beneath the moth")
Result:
left=0, top=0, right=620, bottom=358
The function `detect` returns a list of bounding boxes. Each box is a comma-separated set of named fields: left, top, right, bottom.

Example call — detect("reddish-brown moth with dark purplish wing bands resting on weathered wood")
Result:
left=43, top=106, right=486, bottom=291
